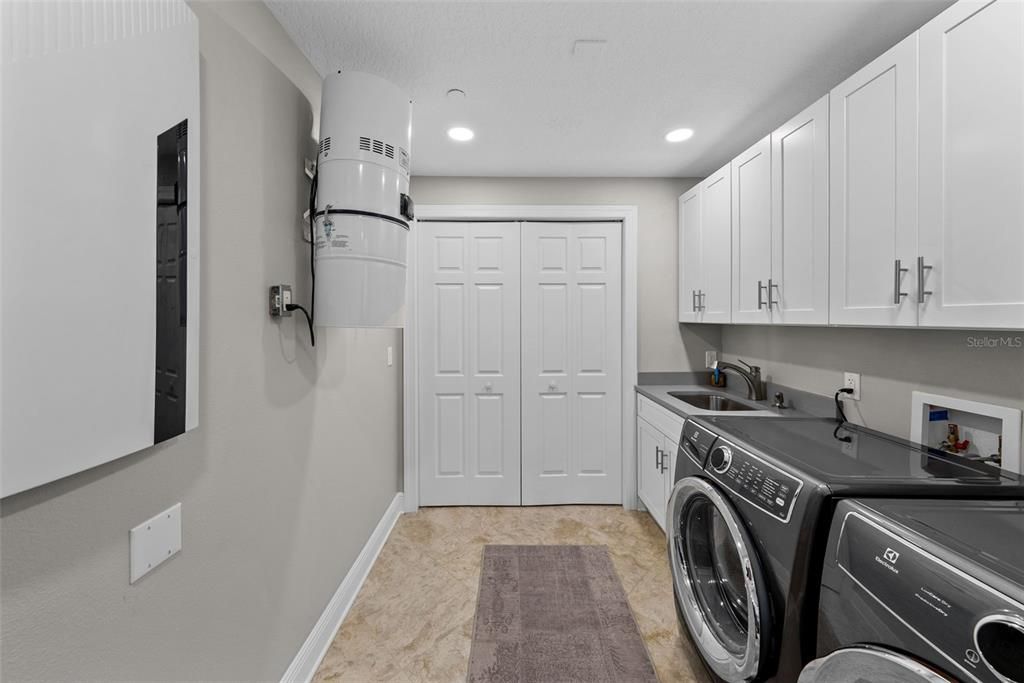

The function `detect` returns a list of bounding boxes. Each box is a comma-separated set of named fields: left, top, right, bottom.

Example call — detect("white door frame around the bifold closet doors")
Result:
left=402, top=204, right=639, bottom=512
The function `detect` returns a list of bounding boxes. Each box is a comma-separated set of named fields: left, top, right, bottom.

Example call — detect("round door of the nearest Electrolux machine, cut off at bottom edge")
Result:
left=798, top=645, right=952, bottom=683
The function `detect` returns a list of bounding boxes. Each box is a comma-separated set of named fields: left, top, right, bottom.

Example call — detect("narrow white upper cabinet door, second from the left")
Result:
left=697, top=165, right=732, bottom=323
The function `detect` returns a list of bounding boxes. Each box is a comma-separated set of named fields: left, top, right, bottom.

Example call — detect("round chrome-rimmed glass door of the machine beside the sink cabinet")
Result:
left=669, top=477, right=771, bottom=682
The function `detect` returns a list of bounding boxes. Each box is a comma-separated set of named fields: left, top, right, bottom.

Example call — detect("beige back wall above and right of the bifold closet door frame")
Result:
left=410, top=176, right=720, bottom=372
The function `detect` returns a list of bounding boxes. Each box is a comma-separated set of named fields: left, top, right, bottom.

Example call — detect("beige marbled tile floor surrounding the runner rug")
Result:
left=315, top=506, right=708, bottom=683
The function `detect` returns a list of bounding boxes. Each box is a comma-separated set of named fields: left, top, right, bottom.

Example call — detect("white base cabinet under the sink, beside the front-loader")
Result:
left=637, top=394, right=685, bottom=531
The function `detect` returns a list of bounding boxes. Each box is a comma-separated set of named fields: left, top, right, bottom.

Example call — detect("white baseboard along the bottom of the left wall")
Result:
left=281, top=492, right=402, bottom=683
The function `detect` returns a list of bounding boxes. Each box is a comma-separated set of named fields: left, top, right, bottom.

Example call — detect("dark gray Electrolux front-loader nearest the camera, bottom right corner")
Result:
left=800, top=500, right=1024, bottom=683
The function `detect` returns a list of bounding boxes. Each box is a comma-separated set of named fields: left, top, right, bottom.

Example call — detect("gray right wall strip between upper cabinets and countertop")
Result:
left=722, top=325, right=1024, bottom=437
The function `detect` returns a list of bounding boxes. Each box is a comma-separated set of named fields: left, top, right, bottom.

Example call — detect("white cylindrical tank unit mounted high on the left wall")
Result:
left=313, top=72, right=414, bottom=328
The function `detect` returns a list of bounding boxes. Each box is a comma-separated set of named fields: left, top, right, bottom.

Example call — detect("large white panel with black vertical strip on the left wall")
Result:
left=0, top=0, right=200, bottom=496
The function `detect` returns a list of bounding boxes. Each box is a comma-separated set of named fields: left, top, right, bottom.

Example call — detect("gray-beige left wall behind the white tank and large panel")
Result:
left=0, top=3, right=401, bottom=681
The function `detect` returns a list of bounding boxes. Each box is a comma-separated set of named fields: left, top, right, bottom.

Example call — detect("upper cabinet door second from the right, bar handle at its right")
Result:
left=828, top=34, right=918, bottom=326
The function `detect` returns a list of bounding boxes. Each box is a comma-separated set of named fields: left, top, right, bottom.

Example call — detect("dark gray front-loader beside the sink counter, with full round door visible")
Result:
left=667, top=416, right=1024, bottom=682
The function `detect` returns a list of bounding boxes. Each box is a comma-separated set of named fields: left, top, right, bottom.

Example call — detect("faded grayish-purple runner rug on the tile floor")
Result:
left=467, top=546, right=657, bottom=683
